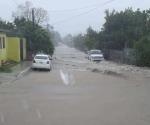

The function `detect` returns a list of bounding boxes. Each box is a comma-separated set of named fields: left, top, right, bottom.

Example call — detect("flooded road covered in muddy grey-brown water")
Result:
left=0, top=46, right=150, bottom=125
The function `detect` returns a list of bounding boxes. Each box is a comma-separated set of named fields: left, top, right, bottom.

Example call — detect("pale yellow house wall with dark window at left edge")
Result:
left=0, top=33, right=7, bottom=66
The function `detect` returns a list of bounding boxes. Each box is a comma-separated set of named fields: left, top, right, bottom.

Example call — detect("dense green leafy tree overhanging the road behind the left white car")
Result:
left=14, top=18, right=54, bottom=54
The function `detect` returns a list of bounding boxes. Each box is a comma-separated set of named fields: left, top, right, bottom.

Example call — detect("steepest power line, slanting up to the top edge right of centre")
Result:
left=53, top=0, right=115, bottom=25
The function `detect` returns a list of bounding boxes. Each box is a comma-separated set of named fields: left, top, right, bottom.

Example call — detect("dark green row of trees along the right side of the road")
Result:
left=68, top=8, right=150, bottom=66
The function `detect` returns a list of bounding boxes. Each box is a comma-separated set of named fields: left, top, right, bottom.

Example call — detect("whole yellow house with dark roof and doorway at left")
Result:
left=0, top=29, right=26, bottom=65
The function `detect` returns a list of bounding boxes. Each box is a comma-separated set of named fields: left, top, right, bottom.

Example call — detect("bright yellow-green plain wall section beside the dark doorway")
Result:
left=7, top=37, right=20, bottom=62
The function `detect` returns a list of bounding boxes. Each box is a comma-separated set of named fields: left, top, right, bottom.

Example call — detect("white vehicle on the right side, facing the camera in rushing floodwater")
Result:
left=88, top=50, right=104, bottom=61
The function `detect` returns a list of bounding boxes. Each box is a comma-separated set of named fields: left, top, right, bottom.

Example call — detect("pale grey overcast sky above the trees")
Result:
left=0, top=0, right=150, bottom=36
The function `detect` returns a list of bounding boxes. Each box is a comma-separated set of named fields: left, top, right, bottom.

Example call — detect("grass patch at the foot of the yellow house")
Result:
left=0, top=61, right=18, bottom=73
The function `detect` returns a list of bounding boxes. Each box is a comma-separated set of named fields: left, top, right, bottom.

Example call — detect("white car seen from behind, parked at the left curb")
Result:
left=32, top=54, right=52, bottom=71
